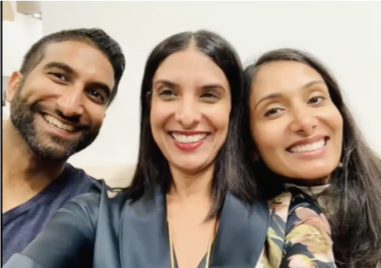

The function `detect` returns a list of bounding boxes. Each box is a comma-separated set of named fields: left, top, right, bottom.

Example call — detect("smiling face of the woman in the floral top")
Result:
left=250, top=61, right=343, bottom=180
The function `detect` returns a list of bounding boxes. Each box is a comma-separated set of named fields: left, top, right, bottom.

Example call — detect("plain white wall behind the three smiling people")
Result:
left=42, top=0, right=381, bottom=165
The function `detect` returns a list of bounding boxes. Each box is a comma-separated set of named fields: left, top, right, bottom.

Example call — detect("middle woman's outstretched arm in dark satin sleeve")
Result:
left=3, top=193, right=99, bottom=268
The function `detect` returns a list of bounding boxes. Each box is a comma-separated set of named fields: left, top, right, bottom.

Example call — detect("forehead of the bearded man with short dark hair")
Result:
left=36, top=41, right=114, bottom=88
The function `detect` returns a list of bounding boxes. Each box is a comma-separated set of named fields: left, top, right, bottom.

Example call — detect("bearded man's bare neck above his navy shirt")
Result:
left=3, top=120, right=65, bottom=212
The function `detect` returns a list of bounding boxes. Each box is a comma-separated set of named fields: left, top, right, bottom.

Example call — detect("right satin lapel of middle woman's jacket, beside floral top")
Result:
left=210, top=194, right=270, bottom=268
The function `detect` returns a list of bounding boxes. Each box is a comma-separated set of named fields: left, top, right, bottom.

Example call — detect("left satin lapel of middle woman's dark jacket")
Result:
left=119, top=188, right=171, bottom=268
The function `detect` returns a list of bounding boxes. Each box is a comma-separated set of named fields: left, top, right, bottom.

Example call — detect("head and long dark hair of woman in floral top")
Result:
left=245, top=49, right=381, bottom=268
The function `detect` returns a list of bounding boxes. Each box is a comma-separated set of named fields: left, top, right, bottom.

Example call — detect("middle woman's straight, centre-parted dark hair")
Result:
left=129, top=30, right=257, bottom=216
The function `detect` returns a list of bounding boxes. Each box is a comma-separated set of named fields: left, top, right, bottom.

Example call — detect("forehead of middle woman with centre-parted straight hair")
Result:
left=154, top=48, right=228, bottom=84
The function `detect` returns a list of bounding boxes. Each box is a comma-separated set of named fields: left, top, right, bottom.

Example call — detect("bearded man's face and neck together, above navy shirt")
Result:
left=2, top=41, right=115, bottom=213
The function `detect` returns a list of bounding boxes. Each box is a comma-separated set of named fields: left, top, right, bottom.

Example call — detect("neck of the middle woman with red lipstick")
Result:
left=169, top=163, right=214, bottom=201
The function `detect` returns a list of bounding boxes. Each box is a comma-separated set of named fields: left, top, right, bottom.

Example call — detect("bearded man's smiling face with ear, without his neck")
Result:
left=7, top=41, right=114, bottom=160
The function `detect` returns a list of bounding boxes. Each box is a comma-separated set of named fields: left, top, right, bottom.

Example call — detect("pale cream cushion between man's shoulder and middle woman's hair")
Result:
left=76, top=164, right=136, bottom=187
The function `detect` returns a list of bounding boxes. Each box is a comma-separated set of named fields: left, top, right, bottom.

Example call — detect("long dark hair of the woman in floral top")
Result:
left=244, top=49, right=381, bottom=268
